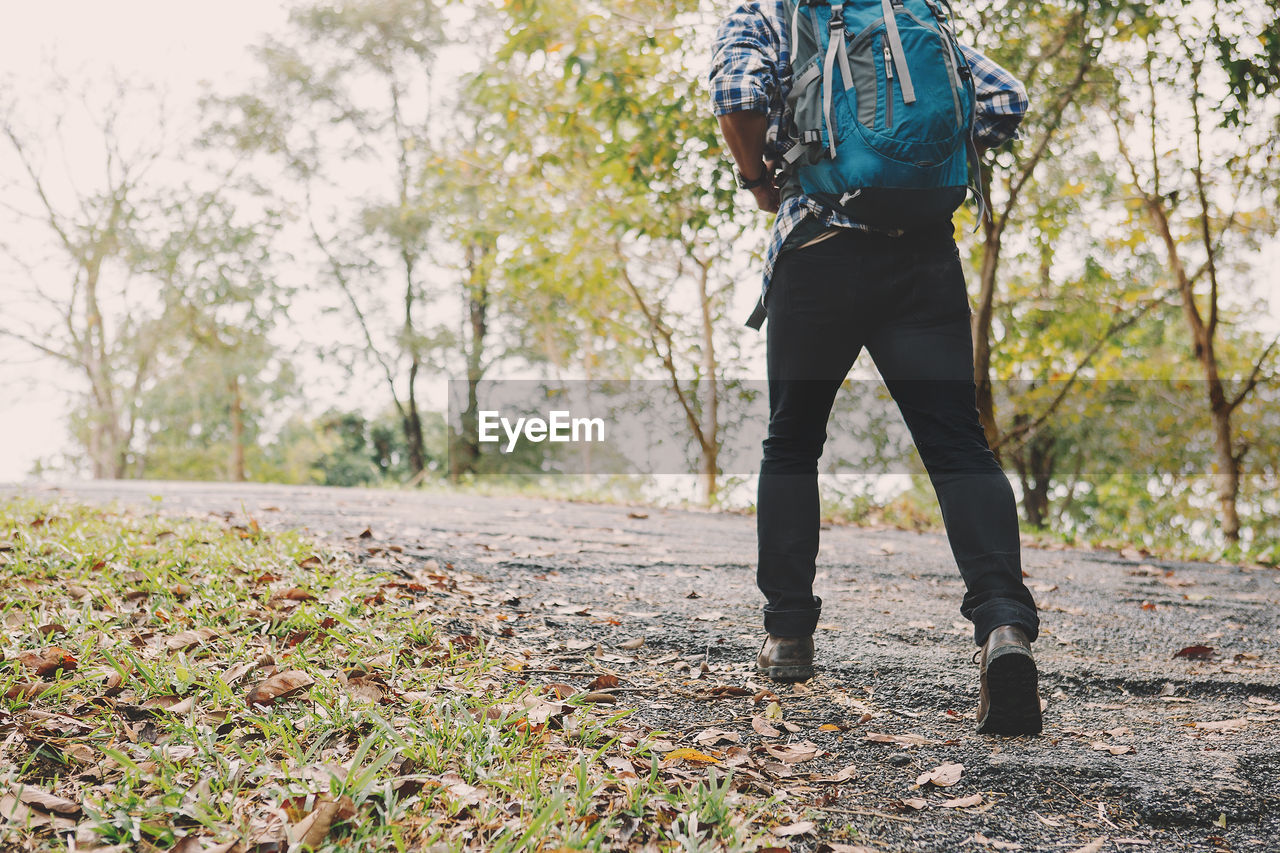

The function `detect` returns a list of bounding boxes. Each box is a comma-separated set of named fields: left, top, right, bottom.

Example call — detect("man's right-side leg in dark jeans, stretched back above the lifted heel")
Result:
left=867, top=234, right=1039, bottom=646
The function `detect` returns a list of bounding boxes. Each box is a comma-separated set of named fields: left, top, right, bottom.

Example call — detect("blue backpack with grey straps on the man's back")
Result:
left=782, top=0, right=977, bottom=229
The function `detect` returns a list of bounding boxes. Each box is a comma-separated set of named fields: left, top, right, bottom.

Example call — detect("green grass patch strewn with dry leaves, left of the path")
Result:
left=0, top=500, right=772, bottom=850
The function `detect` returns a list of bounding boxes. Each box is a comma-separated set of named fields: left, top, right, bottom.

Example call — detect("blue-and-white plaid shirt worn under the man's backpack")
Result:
left=710, top=0, right=1028, bottom=322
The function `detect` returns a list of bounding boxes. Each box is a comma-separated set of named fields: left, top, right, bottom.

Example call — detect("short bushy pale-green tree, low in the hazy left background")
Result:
left=137, top=186, right=296, bottom=482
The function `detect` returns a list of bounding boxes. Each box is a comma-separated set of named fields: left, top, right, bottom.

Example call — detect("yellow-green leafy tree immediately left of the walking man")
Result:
left=486, top=0, right=744, bottom=502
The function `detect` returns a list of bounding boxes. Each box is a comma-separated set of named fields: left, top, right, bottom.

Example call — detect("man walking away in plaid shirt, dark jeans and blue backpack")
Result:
left=710, top=0, right=1041, bottom=734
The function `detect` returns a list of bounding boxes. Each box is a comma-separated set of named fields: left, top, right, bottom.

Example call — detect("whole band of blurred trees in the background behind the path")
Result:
left=0, top=0, right=1280, bottom=562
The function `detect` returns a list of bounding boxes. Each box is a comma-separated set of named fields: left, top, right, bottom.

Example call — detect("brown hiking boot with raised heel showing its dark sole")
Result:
left=974, top=625, right=1042, bottom=735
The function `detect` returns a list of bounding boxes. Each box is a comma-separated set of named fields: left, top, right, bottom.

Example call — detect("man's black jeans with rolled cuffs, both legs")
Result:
left=756, top=223, right=1039, bottom=646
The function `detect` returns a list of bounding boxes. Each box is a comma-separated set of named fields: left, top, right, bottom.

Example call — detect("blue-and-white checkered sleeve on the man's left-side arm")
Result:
left=710, top=0, right=781, bottom=115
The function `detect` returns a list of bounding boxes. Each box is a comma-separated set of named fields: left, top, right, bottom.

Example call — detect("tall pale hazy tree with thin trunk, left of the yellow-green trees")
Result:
left=210, top=0, right=443, bottom=475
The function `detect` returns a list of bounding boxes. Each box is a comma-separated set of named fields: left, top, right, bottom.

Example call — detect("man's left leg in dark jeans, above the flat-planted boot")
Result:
left=756, top=234, right=867, bottom=637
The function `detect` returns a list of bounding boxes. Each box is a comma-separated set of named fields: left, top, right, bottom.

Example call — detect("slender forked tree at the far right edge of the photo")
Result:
left=1111, top=3, right=1280, bottom=542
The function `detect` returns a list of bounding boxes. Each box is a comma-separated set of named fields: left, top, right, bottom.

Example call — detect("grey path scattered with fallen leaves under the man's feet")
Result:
left=24, top=483, right=1280, bottom=852
